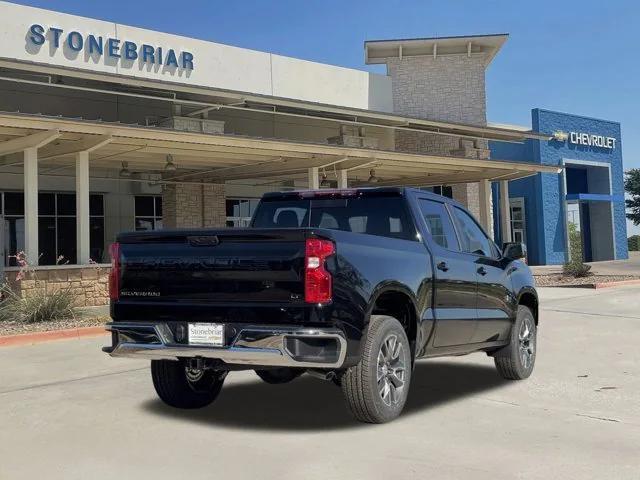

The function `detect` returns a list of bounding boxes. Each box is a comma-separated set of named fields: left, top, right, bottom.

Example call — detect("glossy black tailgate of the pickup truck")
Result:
left=118, top=229, right=306, bottom=305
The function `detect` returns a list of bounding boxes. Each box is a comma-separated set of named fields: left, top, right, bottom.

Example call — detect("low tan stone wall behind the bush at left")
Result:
left=6, top=265, right=110, bottom=307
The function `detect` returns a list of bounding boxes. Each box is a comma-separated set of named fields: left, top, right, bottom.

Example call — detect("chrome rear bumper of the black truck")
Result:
left=102, top=322, right=347, bottom=368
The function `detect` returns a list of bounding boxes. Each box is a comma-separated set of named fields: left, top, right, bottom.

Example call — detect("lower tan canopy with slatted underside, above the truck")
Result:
left=0, top=113, right=560, bottom=186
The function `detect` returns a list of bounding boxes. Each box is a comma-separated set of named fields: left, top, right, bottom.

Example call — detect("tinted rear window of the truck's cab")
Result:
left=251, top=196, right=416, bottom=240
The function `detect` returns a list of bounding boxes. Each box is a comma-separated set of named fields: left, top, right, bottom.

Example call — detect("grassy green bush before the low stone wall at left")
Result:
left=0, top=284, right=75, bottom=323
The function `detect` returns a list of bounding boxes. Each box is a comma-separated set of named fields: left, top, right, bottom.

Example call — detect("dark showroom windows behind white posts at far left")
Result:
left=0, top=192, right=104, bottom=266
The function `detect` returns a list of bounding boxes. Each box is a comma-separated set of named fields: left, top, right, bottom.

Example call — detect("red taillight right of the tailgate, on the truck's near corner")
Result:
left=304, top=238, right=336, bottom=303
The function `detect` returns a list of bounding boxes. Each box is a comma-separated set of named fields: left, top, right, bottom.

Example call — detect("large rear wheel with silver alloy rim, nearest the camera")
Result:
left=340, top=315, right=412, bottom=423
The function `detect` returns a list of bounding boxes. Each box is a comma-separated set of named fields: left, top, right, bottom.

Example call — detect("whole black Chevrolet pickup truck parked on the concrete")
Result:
left=103, top=187, right=538, bottom=423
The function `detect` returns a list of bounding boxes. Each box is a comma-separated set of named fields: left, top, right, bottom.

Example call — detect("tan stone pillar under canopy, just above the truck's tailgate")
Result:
left=162, top=183, right=226, bottom=228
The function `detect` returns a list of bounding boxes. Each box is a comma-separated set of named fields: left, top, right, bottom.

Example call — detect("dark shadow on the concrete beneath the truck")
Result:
left=142, top=360, right=509, bottom=431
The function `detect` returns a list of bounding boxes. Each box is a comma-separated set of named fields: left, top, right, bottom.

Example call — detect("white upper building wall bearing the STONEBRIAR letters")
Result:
left=0, top=1, right=393, bottom=111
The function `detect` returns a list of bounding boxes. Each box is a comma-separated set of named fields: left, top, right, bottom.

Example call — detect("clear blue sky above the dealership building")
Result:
left=15, top=0, right=640, bottom=233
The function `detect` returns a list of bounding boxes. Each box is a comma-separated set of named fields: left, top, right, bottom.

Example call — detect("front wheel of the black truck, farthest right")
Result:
left=493, top=305, right=538, bottom=380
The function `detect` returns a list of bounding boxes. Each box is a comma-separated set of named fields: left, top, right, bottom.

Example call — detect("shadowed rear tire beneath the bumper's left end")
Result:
left=151, top=360, right=225, bottom=409
